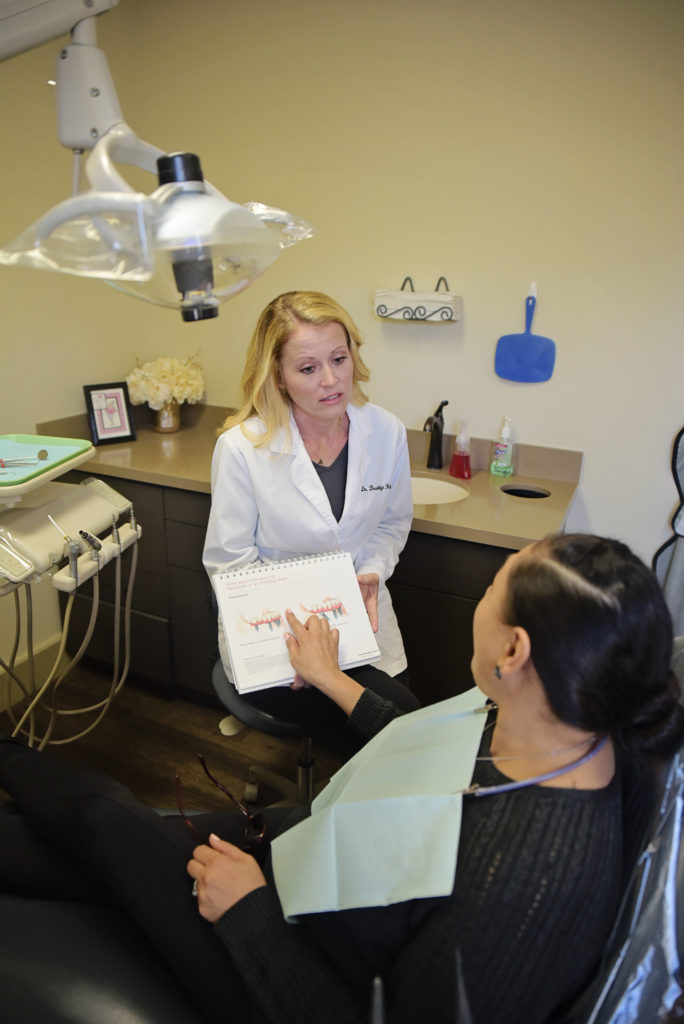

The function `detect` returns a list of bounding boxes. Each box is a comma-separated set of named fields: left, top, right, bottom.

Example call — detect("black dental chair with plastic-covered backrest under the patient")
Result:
left=0, top=638, right=684, bottom=1024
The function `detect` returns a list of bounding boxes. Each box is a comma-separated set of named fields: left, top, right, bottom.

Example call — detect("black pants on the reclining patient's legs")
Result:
left=0, top=741, right=290, bottom=1024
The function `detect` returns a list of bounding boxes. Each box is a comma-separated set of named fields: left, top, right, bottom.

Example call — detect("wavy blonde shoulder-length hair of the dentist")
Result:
left=221, top=292, right=371, bottom=447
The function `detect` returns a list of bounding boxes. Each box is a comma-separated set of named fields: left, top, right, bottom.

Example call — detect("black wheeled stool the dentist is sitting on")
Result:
left=211, top=660, right=327, bottom=804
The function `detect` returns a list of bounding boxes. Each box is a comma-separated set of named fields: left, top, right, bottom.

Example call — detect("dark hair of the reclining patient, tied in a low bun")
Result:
left=505, top=534, right=684, bottom=757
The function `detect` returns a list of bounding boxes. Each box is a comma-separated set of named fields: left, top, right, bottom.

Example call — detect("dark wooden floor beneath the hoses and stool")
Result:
left=0, top=665, right=341, bottom=810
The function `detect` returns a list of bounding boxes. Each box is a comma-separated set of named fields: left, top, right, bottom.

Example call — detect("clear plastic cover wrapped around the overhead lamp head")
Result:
left=0, top=191, right=315, bottom=308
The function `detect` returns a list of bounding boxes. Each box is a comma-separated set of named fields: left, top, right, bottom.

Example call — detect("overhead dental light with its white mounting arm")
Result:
left=0, top=0, right=315, bottom=322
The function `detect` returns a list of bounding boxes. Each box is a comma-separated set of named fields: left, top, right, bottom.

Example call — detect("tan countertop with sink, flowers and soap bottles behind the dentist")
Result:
left=36, top=404, right=582, bottom=549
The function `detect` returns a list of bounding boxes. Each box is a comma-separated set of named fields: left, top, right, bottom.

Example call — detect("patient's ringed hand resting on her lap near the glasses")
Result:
left=187, top=834, right=266, bottom=924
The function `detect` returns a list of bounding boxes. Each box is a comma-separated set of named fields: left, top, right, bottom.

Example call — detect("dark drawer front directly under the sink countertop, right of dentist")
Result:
left=392, top=531, right=511, bottom=600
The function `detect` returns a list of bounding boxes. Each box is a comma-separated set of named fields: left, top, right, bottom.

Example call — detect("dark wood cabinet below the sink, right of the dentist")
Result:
left=388, top=532, right=511, bottom=705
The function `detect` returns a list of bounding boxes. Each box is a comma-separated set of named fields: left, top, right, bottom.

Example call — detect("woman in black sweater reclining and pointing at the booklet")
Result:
left=0, top=535, right=684, bottom=1024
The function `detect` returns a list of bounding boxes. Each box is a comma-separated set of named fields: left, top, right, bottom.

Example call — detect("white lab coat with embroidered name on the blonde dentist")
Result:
left=203, top=403, right=413, bottom=676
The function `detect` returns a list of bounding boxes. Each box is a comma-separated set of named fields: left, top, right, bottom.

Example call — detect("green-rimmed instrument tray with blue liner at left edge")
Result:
left=0, top=434, right=95, bottom=505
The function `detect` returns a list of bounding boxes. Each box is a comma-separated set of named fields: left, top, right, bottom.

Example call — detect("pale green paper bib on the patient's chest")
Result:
left=271, top=688, right=486, bottom=920
